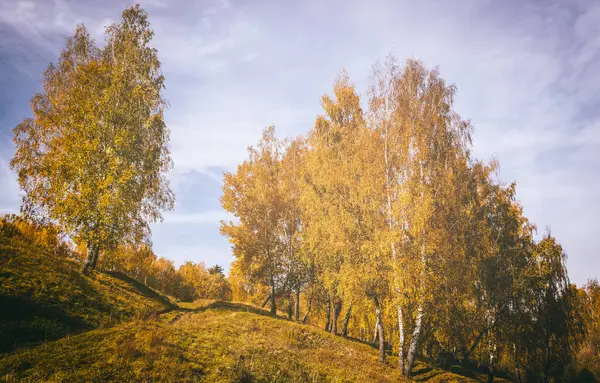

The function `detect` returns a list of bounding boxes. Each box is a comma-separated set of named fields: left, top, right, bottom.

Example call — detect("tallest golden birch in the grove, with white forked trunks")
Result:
left=370, top=57, right=471, bottom=376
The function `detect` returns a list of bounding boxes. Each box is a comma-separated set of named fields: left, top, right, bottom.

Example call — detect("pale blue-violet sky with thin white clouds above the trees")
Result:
left=0, top=0, right=600, bottom=284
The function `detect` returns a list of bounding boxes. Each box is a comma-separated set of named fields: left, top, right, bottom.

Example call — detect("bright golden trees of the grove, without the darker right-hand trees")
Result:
left=222, top=57, right=478, bottom=373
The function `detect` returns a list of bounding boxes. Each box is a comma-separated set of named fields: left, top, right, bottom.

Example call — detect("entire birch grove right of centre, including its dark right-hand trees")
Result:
left=221, top=56, right=584, bottom=381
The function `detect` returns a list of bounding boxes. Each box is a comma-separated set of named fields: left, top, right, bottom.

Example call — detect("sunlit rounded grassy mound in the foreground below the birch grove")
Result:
left=0, top=302, right=508, bottom=382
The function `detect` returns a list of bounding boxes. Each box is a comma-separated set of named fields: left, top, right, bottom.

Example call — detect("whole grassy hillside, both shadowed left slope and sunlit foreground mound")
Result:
left=0, top=226, right=508, bottom=382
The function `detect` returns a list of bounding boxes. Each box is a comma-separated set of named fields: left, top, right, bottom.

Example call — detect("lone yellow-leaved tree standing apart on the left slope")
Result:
left=11, top=6, right=174, bottom=273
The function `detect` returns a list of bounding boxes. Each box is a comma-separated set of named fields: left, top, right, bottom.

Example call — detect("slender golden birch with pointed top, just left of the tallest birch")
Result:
left=302, top=73, right=364, bottom=332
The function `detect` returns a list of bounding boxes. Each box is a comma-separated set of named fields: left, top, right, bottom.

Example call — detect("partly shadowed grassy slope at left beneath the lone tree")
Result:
left=0, top=235, right=176, bottom=353
